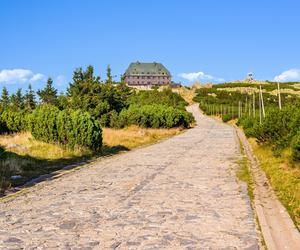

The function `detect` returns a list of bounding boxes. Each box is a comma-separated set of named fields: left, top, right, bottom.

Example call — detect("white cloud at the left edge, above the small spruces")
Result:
left=0, top=69, right=46, bottom=84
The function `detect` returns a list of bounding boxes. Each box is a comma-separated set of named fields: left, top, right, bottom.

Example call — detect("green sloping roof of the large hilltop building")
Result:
left=125, top=62, right=171, bottom=76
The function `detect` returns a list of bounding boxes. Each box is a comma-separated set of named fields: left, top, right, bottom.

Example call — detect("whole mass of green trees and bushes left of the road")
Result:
left=0, top=66, right=193, bottom=150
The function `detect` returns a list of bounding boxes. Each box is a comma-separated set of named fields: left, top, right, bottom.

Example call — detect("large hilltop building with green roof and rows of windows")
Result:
left=124, top=62, right=172, bottom=88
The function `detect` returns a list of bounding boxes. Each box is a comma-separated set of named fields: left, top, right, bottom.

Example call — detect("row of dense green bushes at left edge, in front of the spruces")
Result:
left=0, top=105, right=102, bottom=150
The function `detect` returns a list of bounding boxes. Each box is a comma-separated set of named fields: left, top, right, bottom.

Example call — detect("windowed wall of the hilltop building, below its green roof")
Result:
left=125, top=75, right=171, bottom=86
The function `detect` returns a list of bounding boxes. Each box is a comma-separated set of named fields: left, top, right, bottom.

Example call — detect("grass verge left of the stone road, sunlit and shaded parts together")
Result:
left=0, top=126, right=182, bottom=191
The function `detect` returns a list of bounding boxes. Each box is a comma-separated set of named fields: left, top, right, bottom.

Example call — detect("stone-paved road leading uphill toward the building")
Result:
left=0, top=105, right=258, bottom=249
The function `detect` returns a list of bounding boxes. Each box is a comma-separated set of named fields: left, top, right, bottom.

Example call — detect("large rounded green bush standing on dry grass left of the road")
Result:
left=31, top=105, right=102, bottom=150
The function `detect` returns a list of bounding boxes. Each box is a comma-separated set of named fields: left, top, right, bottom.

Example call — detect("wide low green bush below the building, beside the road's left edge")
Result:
left=112, top=105, right=194, bottom=128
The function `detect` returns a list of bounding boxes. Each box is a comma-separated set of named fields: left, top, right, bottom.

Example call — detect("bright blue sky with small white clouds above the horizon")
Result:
left=0, top=0, right=300, bottom=92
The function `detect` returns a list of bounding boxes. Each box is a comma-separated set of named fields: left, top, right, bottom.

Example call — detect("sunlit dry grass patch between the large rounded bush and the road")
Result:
left=103, top=126, right=182, bottom=149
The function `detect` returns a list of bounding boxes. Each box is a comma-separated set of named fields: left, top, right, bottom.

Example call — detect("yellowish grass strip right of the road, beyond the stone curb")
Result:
left=249, top=139, right=300, bottom=229
